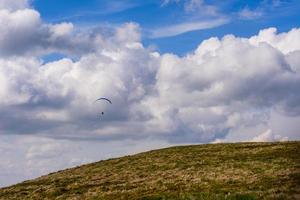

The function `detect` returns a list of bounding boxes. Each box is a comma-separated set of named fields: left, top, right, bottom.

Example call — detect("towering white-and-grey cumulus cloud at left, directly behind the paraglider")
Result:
left=0, top=23, right=158, bottom=140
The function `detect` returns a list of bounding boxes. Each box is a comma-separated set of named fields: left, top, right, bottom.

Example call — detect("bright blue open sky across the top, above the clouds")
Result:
left=33, top=0, right=300, bottom=55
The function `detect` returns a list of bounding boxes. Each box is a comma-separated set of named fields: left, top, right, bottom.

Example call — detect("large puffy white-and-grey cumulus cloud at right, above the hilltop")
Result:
left=145, top=29, right=300, bottom=141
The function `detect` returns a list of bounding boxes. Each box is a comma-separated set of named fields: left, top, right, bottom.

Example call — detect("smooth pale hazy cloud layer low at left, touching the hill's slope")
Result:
left=0, top=135, right=170, bottom=187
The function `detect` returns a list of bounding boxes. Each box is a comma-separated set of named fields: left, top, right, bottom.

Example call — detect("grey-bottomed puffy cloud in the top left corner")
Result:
left=0, top=3, right=103, bottom=57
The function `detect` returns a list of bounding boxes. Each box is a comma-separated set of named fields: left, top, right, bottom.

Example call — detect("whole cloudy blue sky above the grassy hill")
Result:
left=0, top=0, right=300, bottom=187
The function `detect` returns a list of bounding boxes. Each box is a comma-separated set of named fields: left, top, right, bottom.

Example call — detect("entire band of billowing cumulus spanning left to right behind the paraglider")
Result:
left=0, top=19, right=300, bottom=143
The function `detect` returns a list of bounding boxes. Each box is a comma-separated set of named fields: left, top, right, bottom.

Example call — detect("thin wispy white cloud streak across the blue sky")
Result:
left=150, top=18, right=229, bottom=38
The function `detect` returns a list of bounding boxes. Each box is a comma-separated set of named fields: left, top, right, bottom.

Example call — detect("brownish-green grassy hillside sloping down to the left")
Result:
left=0, top=142, right=300, bottom=200
